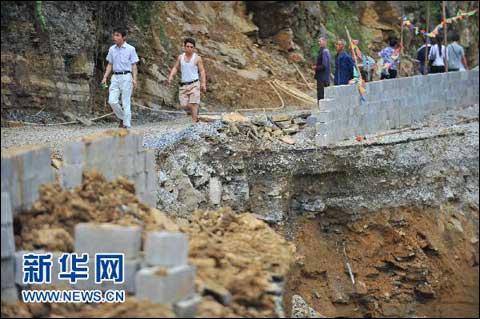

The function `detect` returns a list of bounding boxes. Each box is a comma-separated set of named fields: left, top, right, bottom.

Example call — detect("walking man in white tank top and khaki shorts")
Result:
left=168, top=38, right=207, bottom=123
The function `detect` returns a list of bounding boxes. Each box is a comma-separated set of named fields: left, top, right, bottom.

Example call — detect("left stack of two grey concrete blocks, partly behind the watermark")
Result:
left=75, top=223, right=142, bottom=293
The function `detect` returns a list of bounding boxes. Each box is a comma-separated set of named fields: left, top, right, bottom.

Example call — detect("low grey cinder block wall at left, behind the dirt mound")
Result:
left=1, top=130, right=157, bottom=303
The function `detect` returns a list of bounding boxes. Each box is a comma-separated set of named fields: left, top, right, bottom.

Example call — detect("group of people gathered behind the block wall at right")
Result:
left=312, top=32, right=468, bottom=100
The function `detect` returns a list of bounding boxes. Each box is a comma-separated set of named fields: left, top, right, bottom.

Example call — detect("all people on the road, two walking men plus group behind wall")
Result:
left=102, top=28, right=467, bottom=128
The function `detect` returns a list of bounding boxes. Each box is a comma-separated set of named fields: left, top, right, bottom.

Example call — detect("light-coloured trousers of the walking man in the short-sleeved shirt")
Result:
left=108, top=73, right=133, bottom=127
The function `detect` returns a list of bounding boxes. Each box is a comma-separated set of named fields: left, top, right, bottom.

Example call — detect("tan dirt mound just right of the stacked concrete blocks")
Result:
left=182, top=209, right=294, bottom=317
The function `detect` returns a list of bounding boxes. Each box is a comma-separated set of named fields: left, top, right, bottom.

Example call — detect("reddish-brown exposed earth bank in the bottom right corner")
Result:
left=285, top=206, right=479, bottom=317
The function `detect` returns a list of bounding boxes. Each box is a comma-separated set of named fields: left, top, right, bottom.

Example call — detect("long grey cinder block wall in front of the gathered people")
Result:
left=313, top=70, right=479, bottom=146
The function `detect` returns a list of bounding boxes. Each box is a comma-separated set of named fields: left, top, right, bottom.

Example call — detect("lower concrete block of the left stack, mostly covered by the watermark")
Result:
left=74, top=256, right=142, bottom=294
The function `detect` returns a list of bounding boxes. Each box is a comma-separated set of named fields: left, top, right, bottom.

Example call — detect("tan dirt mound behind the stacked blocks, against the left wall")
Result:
left=15, top=171, right=178, bottom=252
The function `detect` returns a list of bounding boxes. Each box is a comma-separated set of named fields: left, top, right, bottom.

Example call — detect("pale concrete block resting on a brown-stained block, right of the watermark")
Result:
left=144, top=231, right=188, bottom=267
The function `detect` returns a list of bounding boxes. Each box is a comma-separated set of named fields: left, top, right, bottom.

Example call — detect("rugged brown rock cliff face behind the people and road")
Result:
left=1, top=1, right=478, bottom=117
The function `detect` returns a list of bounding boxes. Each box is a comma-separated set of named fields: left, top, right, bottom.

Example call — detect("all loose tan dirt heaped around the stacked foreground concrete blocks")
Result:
left=11, top=171, right=294, bottom=317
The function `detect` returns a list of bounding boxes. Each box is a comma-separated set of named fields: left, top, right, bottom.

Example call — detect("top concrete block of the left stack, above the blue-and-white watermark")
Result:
left=75, top=223, right=142, bottom=259
